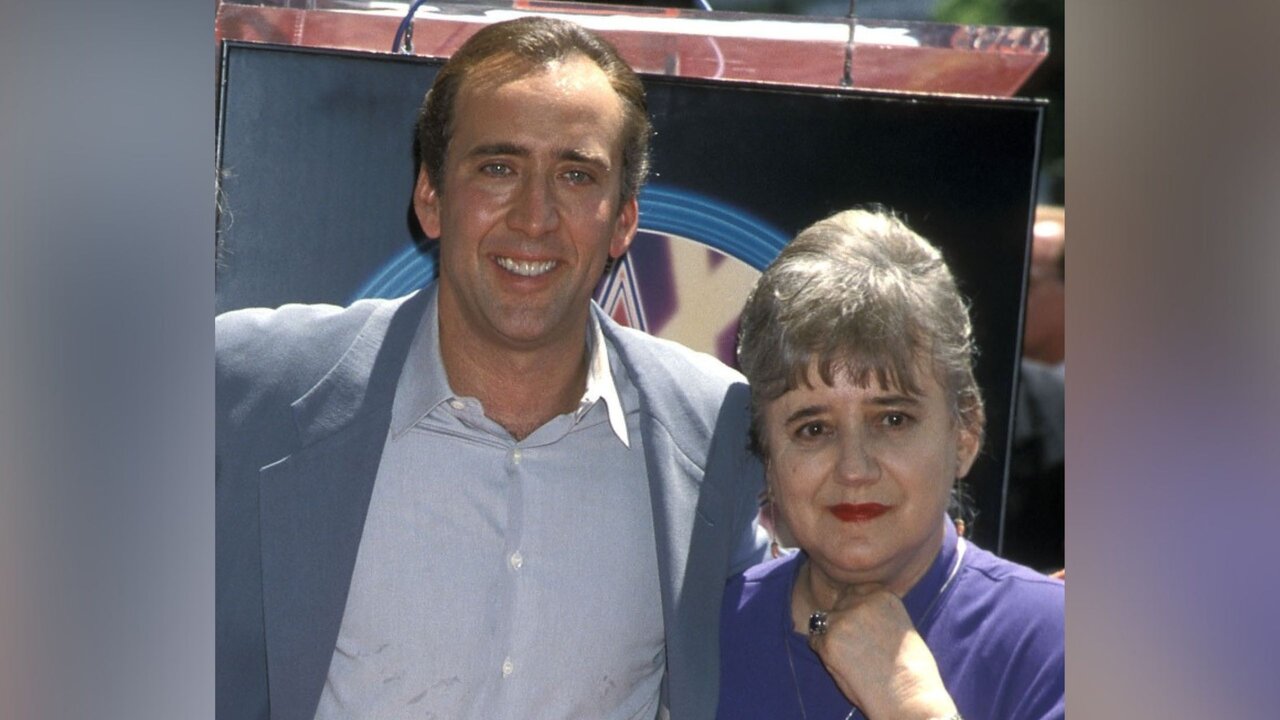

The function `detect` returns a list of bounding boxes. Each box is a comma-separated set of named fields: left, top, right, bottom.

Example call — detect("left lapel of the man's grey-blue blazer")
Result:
left=260, top=286, right=426, bottom=720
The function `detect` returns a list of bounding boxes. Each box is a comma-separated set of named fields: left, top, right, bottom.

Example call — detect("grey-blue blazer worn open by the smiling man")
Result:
left=215, top=285, right=765, bottom=720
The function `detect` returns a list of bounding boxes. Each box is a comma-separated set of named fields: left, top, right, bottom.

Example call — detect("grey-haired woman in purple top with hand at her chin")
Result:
left=719, top=210, right=1065, bottom=720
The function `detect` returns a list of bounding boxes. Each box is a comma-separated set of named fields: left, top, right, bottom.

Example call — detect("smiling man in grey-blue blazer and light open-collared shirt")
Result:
left=216, top=18, right=765, bottom=720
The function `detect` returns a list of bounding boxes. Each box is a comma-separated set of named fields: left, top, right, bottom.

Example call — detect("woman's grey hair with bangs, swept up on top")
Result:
left=737, top=208, right=986, bottom=456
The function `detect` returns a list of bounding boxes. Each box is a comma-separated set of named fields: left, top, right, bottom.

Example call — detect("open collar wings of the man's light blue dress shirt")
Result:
left=392, top=283, right=631, bottom=448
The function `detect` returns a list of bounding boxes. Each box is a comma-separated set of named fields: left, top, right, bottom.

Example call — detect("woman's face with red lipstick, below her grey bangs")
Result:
left=763, top=363, right=978, bottom=594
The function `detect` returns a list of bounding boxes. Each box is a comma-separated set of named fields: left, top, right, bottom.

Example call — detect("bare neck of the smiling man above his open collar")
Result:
left=440, top=307, right=588, bottom=439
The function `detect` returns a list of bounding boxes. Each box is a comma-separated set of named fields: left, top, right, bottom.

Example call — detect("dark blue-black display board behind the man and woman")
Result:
left=216, top=42, right=1043, bottom=550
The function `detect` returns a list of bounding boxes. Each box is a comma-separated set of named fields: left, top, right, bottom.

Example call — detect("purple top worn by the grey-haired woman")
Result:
left=717, top=520, right=1066, bottom=720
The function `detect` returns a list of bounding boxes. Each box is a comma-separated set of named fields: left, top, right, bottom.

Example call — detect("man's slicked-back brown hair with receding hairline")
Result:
left=413, top=17, right=653, bottom=204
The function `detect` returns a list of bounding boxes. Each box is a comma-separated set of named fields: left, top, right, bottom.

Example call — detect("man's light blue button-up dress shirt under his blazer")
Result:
left=316, top=287, right=666, bottom=720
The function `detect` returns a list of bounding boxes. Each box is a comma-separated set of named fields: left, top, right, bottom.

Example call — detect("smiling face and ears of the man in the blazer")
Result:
left=413, top=56, right=637, bottom=350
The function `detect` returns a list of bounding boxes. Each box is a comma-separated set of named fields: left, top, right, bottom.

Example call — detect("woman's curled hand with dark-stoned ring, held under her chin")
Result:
left=809, top=585, right=956, bottom=720
